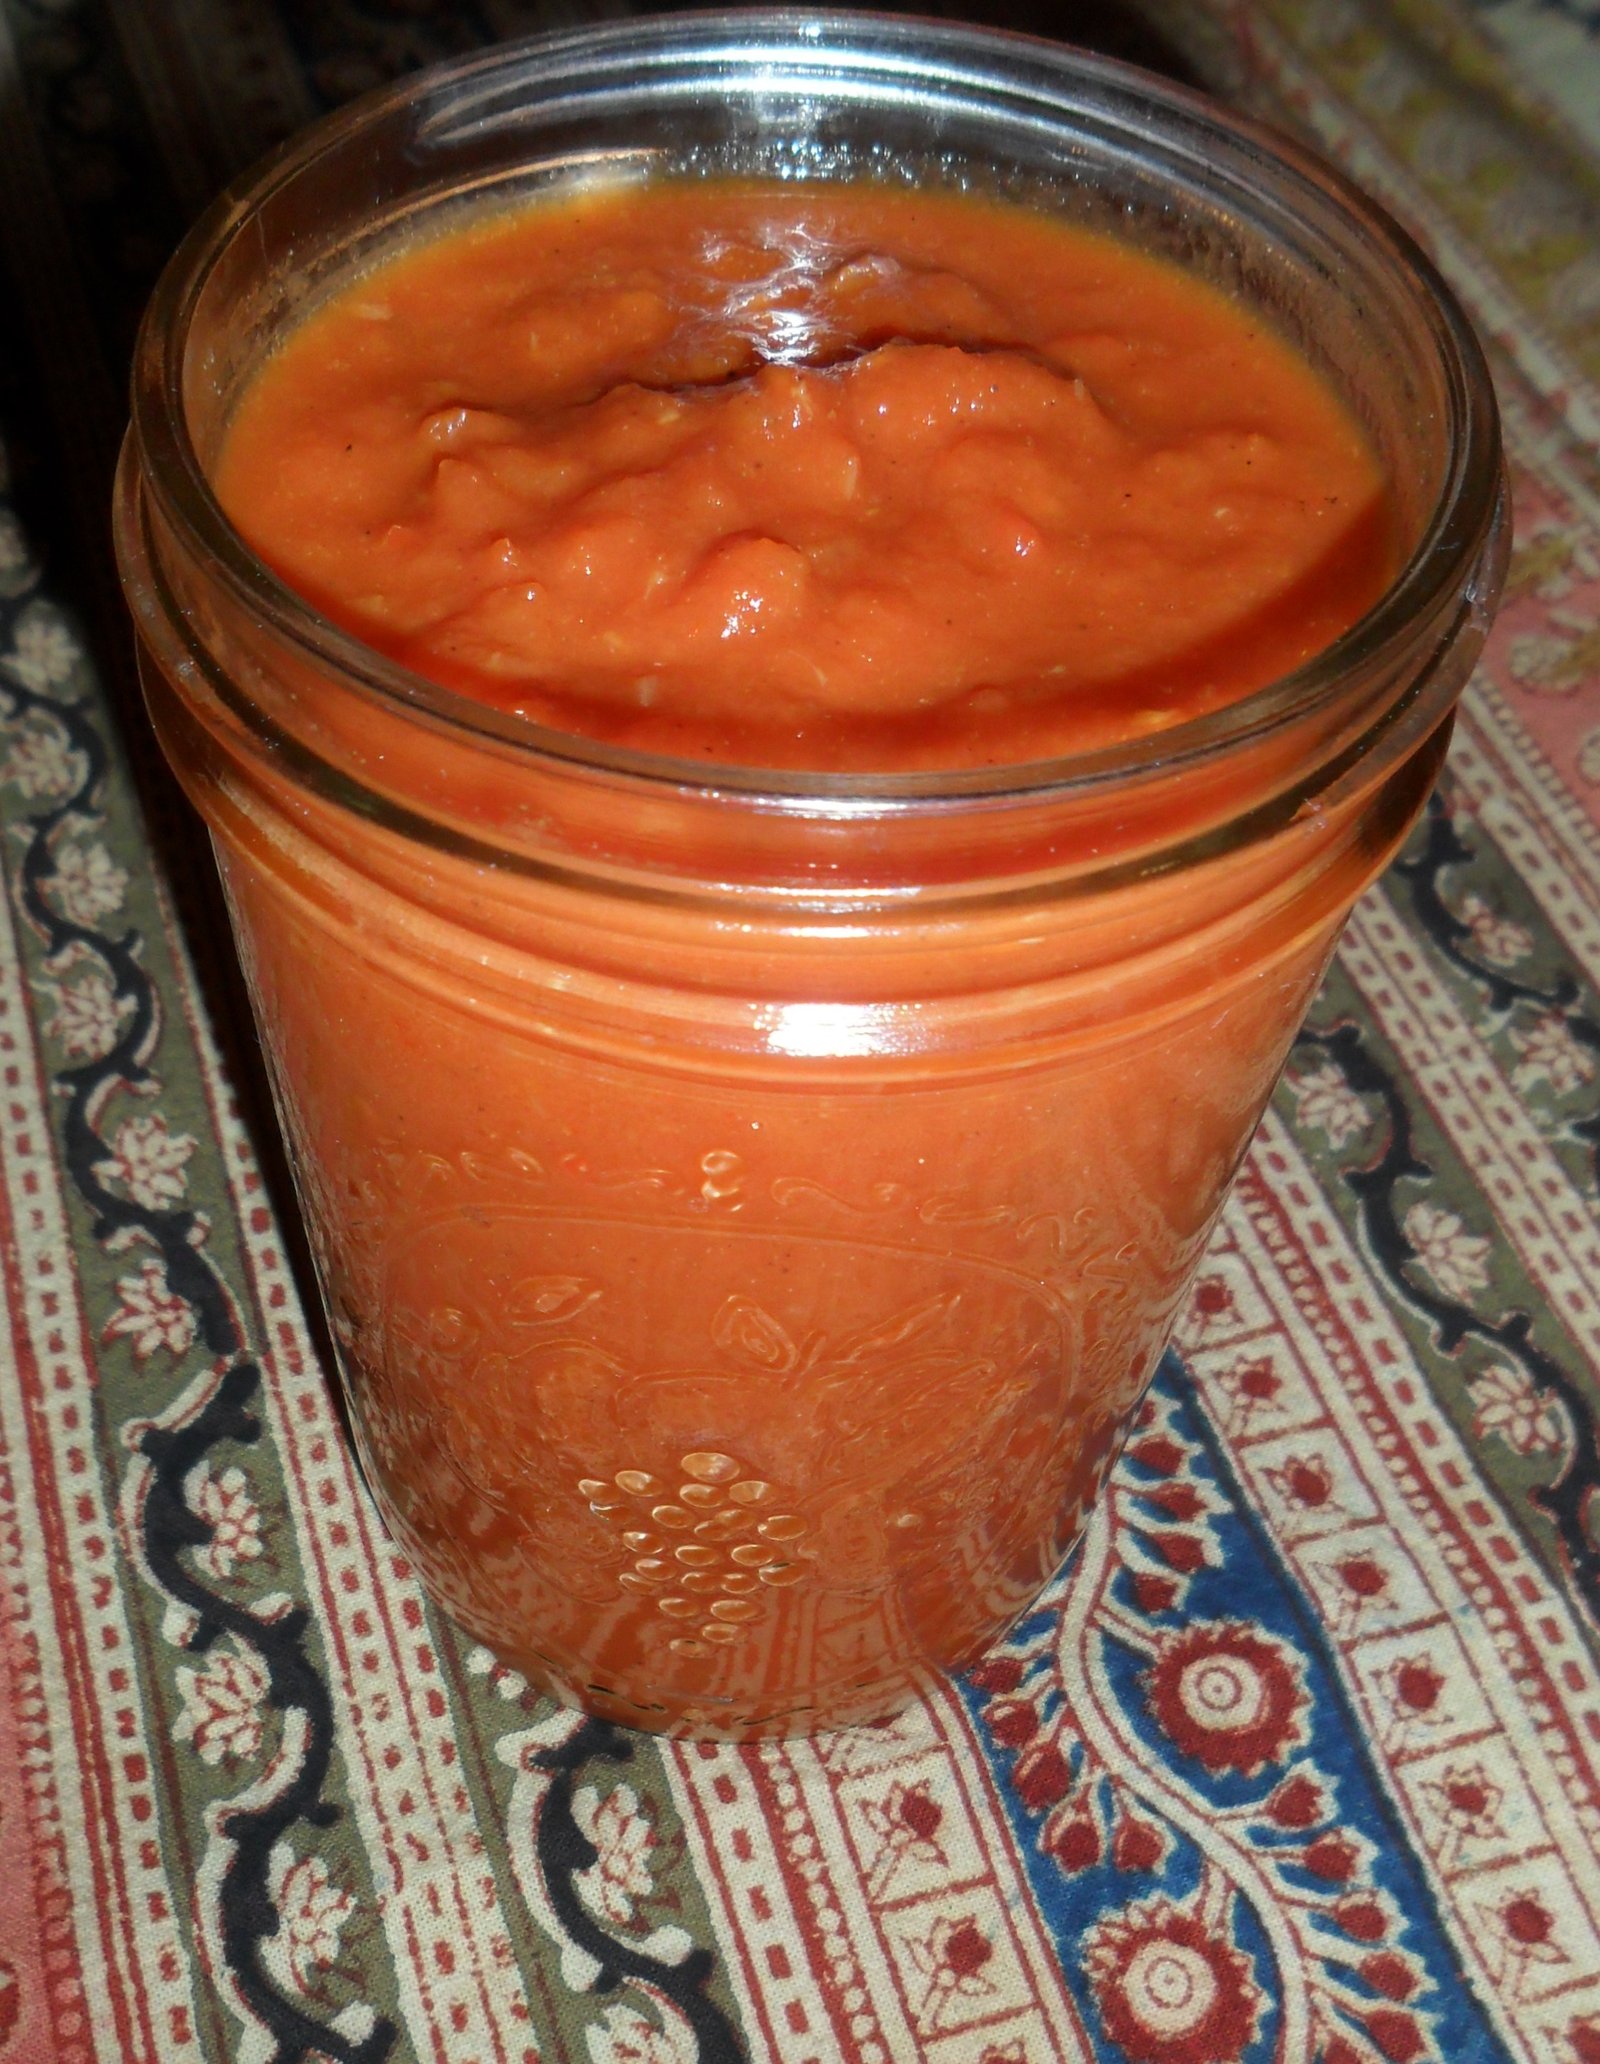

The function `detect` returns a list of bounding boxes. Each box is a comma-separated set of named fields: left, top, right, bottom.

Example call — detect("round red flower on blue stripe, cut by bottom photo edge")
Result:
left=1084, top=1897, right=1266, bottom=2064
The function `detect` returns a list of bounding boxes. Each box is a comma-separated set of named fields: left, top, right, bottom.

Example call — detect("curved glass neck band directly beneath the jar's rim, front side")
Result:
left=118, top=442, right=1509, bottom=921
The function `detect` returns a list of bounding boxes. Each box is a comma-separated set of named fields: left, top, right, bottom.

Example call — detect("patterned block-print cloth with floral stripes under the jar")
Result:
left=0, top=0, right=1600, bottom=2064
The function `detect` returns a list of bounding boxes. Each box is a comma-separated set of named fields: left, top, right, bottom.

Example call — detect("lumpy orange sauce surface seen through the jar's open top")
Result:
left=217, top=182, right=1394, bottom=770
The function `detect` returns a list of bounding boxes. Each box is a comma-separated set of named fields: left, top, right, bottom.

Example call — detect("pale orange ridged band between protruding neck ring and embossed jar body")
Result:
left=140, top=516, right=1449, bottom=1073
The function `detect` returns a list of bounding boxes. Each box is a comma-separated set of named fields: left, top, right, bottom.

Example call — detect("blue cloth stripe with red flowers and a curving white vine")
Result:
left=964, top=1356, right=1532, bottom=2064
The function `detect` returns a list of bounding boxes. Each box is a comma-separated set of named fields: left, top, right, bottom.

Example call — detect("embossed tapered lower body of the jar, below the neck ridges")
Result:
left=223, top=829, right=1330, bottom=1734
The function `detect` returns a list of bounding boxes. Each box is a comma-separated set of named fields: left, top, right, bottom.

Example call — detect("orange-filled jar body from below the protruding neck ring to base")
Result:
left=128, top=652, right=1447, bottom=1738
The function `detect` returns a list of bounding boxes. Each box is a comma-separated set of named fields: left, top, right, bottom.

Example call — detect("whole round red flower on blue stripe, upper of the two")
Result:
left=1144, top=1620, right=1307, bottom=1777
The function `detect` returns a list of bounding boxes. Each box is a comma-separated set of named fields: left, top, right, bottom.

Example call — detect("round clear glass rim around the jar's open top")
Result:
left=121, top=6, right=1503, bottom=817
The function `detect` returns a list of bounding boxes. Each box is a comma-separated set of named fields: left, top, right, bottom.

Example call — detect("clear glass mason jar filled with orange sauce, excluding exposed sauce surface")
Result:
left=118, top=10, right=1507, bottom=1736
